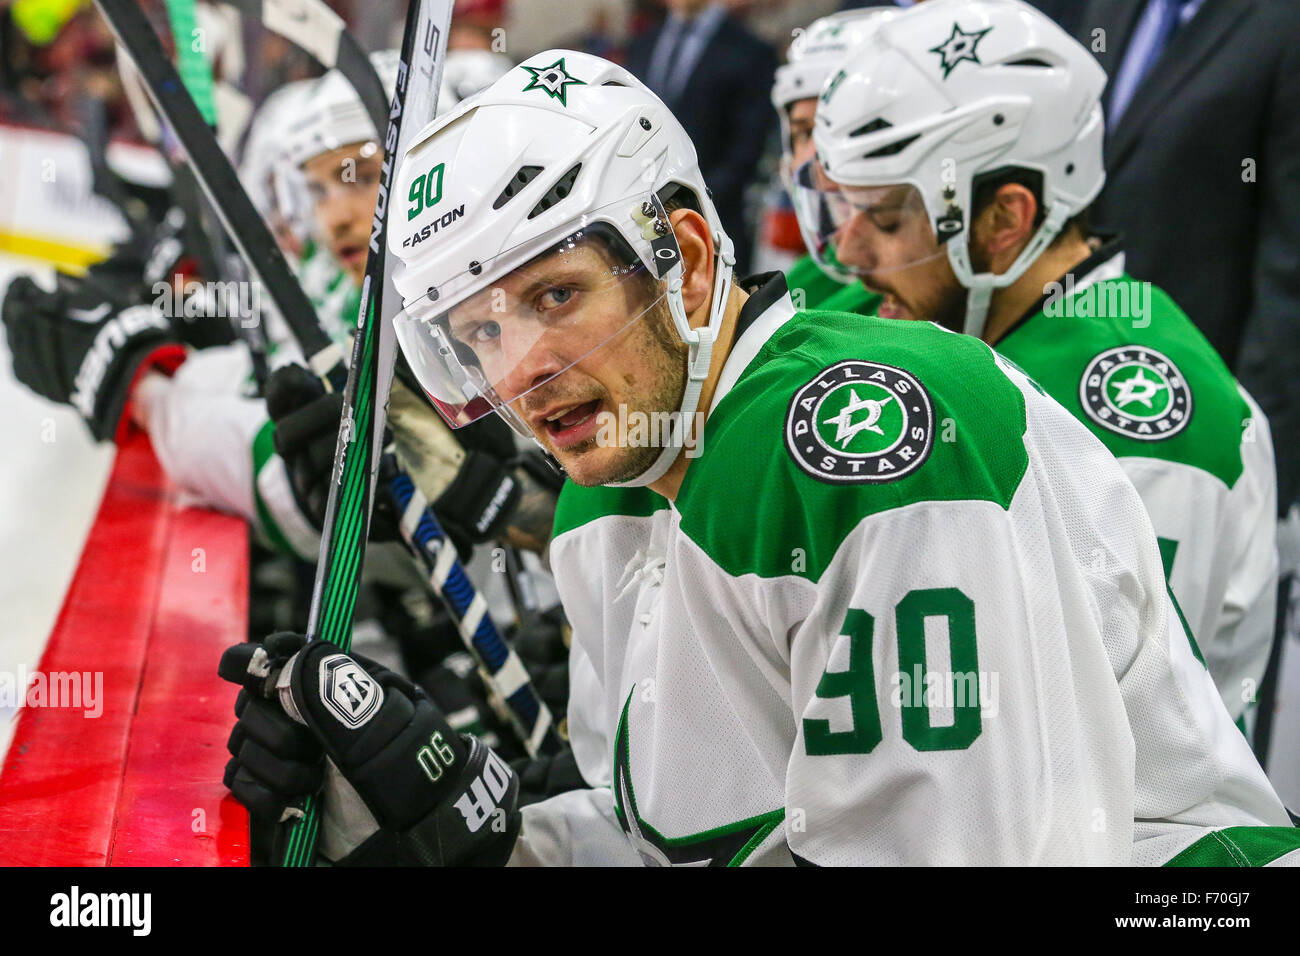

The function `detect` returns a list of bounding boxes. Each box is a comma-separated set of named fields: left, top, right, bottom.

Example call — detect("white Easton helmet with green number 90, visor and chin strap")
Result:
left=387, top=49, right=735, bottom=485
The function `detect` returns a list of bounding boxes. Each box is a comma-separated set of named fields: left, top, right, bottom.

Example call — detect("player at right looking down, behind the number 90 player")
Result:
left=801, top=0, right=1278, bottom=730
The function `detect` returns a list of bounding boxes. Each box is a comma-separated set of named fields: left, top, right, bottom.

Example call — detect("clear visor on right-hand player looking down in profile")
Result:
left=790, top=159, right=946, bottom=286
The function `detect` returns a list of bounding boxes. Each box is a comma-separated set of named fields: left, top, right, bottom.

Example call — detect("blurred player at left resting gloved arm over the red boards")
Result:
left=4, top=52, right=533, bottom=561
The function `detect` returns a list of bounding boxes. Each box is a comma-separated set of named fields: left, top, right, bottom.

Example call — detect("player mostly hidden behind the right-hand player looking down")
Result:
left=772, top=7, right=897, bottom=315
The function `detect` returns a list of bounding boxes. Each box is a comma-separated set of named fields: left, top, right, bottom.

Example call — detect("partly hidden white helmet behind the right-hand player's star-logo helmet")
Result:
left=772, top=7, right=901, bottom=282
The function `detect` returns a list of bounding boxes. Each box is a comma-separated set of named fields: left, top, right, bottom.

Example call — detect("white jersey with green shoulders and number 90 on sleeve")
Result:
left=512, top=280, right=1297, bottom=865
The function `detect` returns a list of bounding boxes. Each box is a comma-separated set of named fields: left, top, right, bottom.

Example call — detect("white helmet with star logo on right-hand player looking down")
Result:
left=811, top=0, right=1106, bottom=336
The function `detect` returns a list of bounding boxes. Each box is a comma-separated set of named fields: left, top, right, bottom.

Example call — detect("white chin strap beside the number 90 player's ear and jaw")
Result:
left=610, top=230, right=736, bottom=488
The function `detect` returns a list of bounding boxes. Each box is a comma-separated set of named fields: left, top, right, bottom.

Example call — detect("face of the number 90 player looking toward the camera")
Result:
left=450, top=242, right=686, bottom=485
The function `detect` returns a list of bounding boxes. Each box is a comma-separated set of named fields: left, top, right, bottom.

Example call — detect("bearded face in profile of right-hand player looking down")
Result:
left=835, top=186, right=966, bottom=330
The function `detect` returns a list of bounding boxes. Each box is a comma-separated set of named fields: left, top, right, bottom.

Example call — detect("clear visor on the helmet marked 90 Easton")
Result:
left=394, top=198, right=681, bottom=436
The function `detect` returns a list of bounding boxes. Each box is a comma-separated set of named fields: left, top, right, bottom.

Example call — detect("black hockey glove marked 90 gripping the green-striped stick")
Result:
left=220, top=635, right=521, bottom=866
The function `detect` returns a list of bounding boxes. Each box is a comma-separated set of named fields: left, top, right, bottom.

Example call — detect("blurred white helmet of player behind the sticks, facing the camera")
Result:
left=282, top=49, right=400, bottom=166
